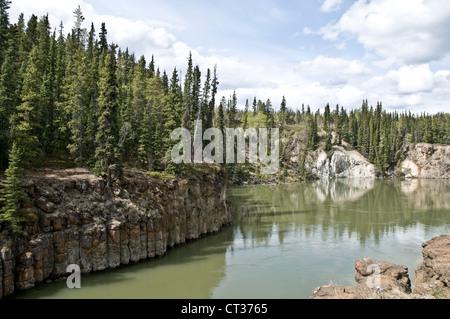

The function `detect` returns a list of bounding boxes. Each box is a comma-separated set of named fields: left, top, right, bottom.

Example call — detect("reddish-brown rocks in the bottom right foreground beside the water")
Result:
left=310, top=235, right=450, bottom=299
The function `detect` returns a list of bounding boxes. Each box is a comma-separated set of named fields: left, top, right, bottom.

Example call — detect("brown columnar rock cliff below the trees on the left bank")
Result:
left=0, top=167, right=232, bottom=298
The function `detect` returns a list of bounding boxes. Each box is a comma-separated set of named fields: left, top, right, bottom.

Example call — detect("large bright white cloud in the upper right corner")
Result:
left=319, top=0, right=450, bottom=64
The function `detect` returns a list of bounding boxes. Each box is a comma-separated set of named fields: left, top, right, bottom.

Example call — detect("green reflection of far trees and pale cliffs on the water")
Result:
left=230, top=179, right=450, bottom=244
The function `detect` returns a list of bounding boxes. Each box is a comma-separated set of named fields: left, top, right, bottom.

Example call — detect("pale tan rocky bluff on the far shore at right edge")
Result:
left=401, top=143, right=450, bottom=179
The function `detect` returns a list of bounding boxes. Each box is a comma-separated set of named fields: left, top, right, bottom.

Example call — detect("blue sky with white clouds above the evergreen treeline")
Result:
left=10, top=0, right=450, bottom=113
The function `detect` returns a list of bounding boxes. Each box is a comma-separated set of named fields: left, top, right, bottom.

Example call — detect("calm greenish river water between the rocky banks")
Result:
left=12, top=180, right=450, bottom=299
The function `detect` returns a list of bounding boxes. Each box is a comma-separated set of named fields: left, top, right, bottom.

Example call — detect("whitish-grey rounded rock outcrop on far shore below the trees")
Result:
left=306, top=142, right=379, bottom=178
